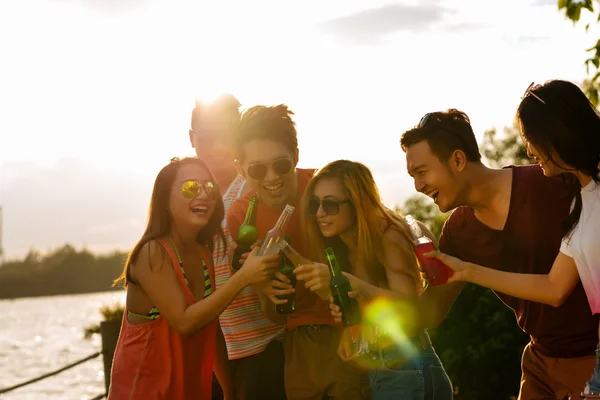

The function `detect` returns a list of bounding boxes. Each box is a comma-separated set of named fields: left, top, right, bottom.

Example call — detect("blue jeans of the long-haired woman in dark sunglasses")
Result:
left=369, top=346, right=453, bottom=400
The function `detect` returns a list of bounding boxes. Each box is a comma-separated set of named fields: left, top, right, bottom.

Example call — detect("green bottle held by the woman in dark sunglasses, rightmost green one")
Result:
left=325, top=247, right=361, bottom=327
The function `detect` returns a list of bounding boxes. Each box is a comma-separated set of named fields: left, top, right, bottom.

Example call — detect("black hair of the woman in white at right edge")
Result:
left=517, top=80, right=600, bottom=236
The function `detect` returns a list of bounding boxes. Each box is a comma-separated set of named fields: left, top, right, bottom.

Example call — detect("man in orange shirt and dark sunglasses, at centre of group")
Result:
left=227, top=104, right=361, bottom=400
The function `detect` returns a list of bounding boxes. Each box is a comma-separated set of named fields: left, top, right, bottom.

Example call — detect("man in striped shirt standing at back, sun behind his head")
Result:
left=189, top=95, right=284, bottom=400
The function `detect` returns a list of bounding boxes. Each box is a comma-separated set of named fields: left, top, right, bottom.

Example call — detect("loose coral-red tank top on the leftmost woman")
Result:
left=108, top=240, right=217, bottom=400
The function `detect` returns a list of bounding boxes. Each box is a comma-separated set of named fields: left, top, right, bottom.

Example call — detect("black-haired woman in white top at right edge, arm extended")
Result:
left=429, top=80, right=600, bottom=399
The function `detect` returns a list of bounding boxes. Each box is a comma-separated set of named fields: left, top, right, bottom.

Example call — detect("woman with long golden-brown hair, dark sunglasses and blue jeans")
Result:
left=298, top=160, right=452, bottom=400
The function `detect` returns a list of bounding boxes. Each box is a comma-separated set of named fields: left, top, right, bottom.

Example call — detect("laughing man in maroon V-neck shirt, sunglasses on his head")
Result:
left=400, top=109, right=598, bottom=400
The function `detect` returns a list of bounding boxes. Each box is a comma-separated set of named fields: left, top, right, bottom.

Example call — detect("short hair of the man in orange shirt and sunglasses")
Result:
left=234, top=104, right=298, bottom=160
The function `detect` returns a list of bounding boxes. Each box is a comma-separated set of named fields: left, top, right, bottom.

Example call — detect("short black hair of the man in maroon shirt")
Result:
left=400, top=108, right=481, bottom=162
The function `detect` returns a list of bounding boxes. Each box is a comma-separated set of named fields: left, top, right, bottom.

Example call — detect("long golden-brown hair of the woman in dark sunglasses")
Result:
left=301, top=160, right=421, bottom=287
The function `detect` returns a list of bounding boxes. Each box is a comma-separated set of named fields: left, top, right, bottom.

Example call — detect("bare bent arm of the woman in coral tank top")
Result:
left=131, top=241, right=279, bottom=336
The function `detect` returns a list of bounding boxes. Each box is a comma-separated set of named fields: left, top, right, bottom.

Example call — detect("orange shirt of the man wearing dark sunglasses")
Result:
left=227, top=168, right=337, bottom=330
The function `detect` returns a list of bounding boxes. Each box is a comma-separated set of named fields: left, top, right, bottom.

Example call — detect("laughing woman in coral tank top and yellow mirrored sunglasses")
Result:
left=108, top=157, right=279, bottom=400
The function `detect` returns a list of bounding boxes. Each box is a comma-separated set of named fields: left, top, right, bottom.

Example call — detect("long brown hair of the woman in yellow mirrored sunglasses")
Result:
left=113, top=157, right=226, bottom=286
